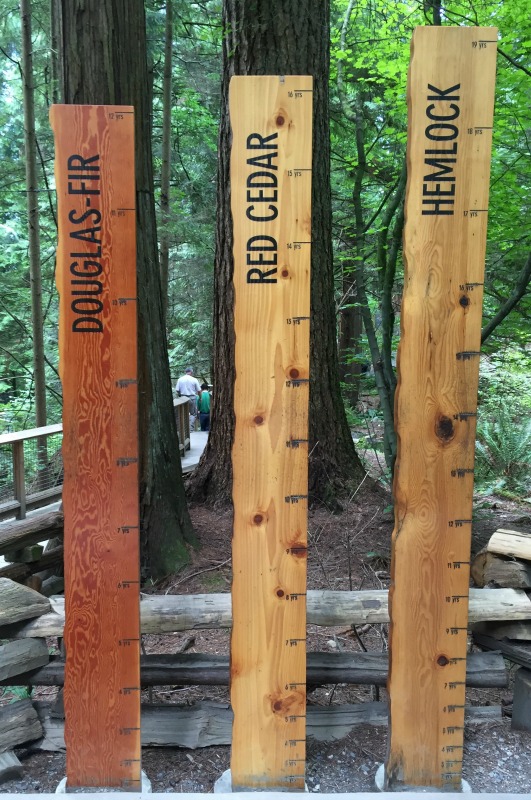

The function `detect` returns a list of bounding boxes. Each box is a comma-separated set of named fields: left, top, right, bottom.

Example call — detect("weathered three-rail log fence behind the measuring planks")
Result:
left=0, top=578, right=531, bottom=760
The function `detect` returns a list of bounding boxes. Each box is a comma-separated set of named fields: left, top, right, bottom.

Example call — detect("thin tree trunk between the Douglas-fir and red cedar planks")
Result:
left=160, top=0, right=173, bottom=316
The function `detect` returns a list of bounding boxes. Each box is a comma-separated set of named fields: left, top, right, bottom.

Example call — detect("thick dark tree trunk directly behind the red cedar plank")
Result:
left=190, top=0, right=364, bottom=502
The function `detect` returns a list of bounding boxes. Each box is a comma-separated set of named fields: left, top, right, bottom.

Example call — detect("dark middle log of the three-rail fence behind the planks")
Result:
left=0, top=640, right=507, bottom=687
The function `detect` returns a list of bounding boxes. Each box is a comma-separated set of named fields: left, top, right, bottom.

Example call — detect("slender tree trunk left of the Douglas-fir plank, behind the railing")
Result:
left=20, top=0, right=47, bottom=454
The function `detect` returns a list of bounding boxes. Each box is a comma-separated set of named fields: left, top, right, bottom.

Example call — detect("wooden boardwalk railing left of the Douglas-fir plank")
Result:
left=0, top=425, right=63, bottom=520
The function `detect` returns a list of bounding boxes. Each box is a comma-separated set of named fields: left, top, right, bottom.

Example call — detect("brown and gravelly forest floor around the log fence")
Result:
left=0, top=450, right=531, bottom=794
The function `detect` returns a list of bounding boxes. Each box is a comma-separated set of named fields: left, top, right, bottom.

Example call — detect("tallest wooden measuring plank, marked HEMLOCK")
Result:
left=385, top=27, right=497, bottom=790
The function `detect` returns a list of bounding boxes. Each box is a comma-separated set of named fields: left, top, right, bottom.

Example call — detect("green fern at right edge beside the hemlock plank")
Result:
left=476, top=403, right=531, bottom=494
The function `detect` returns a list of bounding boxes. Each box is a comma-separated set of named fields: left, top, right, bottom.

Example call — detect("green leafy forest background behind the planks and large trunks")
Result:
left=0, top=0, right=531, bottom=574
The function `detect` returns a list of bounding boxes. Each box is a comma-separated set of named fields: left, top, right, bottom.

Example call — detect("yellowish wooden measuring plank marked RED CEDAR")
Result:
left=230, top=76, right=312, bottom=790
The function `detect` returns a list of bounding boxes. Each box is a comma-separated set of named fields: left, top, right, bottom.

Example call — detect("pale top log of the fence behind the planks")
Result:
left=5, top=589, right=531, bottom=639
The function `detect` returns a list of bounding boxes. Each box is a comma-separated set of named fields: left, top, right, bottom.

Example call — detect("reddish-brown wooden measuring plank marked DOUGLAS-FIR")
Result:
left=50, top=106, right=141, bottom=791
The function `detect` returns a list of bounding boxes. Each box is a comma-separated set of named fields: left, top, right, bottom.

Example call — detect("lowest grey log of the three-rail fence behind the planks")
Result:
left=35, top=701, right=501, bottom=750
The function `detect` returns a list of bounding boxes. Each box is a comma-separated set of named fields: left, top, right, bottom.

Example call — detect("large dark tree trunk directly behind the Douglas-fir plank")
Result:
left=62, top=0, right=196, bottom=578
